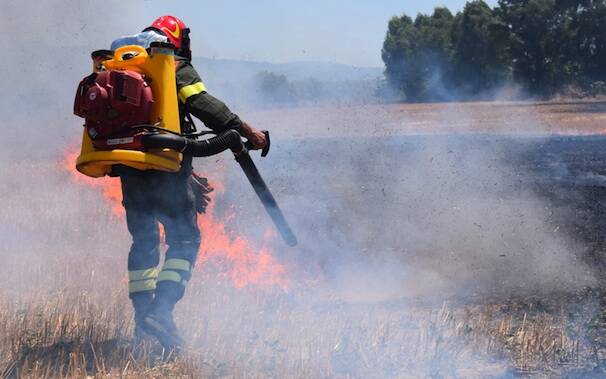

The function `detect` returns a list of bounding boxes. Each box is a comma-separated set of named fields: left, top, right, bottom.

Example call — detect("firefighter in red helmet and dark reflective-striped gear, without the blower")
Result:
left=113, top=16, right=267, bottom=349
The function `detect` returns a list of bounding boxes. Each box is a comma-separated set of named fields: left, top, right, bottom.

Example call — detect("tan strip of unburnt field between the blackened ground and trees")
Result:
left=242, top=100, right=606, bottom=138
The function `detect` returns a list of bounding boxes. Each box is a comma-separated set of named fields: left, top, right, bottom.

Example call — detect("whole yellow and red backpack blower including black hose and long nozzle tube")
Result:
left=74, top=43, right=297, bottom=246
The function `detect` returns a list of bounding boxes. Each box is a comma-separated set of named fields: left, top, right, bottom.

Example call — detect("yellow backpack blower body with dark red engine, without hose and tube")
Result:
left=74, top=43, right=182, bottom=178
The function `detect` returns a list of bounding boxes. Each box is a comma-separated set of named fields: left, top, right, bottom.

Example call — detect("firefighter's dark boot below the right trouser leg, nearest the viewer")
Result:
left=141, top=295, right=183, bottom=351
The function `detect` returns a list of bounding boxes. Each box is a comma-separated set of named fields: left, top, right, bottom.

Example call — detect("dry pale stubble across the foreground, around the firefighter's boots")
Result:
left=0, top=264, right=600, bottom=378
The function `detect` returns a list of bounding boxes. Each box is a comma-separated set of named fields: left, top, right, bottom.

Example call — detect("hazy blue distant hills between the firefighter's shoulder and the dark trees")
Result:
left=193, top=57, right=383, bottom=82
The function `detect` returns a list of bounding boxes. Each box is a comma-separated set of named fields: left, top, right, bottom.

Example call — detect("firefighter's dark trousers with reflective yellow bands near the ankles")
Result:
left=114, top=158, right=200, bottom=305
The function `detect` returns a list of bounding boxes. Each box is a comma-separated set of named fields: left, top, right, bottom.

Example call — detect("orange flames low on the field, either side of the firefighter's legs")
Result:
left=61, top=149, right=289, bottom=290
